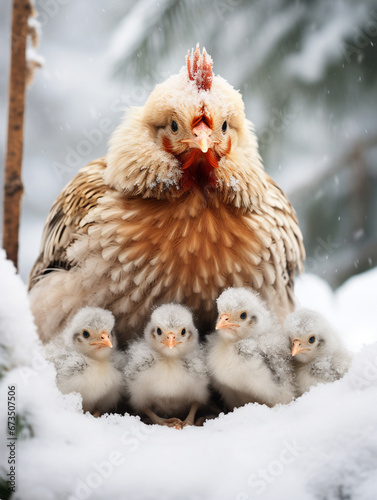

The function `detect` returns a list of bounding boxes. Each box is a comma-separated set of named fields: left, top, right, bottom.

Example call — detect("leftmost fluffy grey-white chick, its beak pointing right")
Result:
left=46, top=307, right=125, bottom=416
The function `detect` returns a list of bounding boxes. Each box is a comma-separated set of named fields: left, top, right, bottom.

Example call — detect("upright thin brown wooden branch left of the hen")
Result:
left=3, top=0, right=32, bottom=267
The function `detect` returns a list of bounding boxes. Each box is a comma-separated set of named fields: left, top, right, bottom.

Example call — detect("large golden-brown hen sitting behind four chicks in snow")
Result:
left=29, top=47, right=304, bottom=344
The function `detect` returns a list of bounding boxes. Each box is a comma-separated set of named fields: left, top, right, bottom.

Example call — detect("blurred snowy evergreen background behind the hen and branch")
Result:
left=0, top=0, right=377, bottom=288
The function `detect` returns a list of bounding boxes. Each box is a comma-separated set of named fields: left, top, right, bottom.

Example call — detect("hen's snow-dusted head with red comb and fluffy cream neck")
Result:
left=104, top=42, right=263, bottom=197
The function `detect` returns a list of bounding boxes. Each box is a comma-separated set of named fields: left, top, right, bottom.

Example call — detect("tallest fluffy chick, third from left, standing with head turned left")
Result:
left=207, top=288, right=295, bottom=410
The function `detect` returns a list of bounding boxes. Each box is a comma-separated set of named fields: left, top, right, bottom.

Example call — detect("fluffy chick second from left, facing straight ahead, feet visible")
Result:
left=125, top=304, right=209, bottom=429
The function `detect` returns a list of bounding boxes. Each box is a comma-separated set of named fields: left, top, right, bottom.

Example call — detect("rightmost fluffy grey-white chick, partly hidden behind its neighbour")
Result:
left=284, top=308, right=351, bottom=396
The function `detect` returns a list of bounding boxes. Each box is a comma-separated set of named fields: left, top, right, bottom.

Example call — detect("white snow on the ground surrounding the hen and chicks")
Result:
left=0, top=253, right=377, bottom=500
